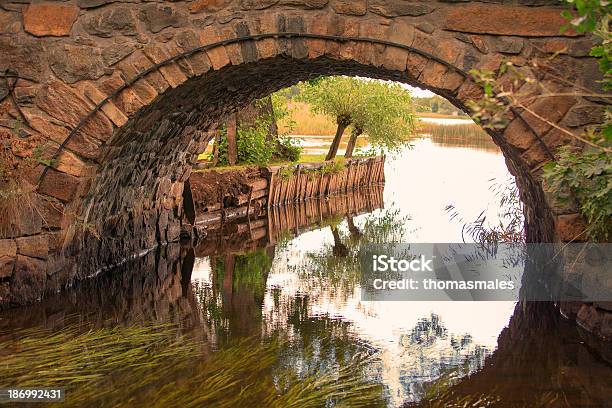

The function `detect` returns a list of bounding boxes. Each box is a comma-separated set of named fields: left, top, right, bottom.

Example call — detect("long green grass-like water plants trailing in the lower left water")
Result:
left=0, top=324, right=383, bottom=407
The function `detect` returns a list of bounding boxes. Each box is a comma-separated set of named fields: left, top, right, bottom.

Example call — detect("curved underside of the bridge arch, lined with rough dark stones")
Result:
left=74, top=55, right=553, bottom=273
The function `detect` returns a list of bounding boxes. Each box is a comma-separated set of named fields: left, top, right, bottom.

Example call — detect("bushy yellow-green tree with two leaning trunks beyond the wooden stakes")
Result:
left=299, top=77, right=414, bottom=160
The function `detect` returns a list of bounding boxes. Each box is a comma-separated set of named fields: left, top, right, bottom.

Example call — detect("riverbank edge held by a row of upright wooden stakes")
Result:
left=189, top=156, right=385, bottom=237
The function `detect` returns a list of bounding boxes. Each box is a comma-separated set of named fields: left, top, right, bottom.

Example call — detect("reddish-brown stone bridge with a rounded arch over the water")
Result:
left=0, top=0, right=602, bottom=334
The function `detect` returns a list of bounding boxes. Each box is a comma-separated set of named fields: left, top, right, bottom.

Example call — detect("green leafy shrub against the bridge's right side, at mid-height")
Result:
left=544, top=149, right=612, bottom=242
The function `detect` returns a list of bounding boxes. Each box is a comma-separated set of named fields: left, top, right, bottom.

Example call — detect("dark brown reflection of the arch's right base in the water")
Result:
left=406, top=302, right=612, bottom=407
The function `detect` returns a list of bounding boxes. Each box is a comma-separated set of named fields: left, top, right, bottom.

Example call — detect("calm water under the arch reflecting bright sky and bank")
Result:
left=0, top=122, right=612, bottom=407
